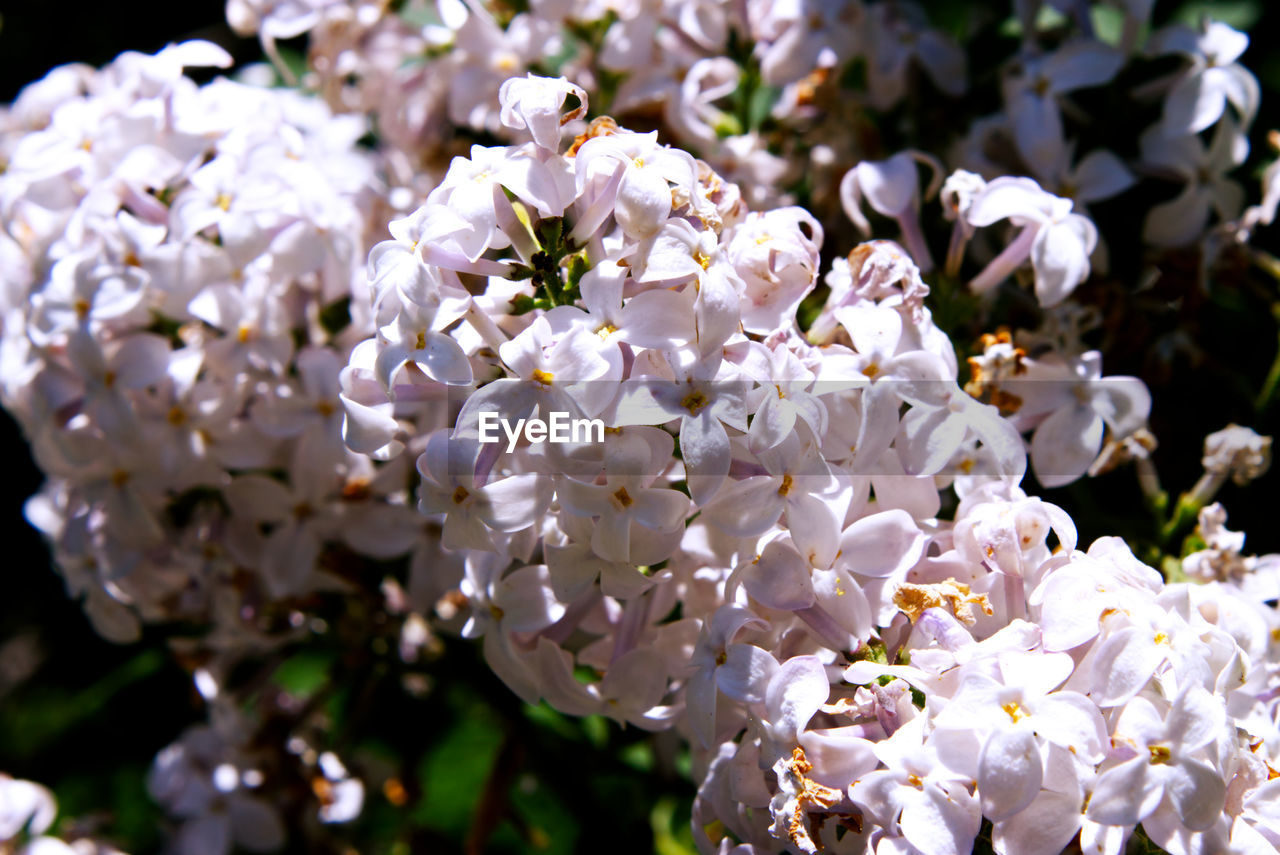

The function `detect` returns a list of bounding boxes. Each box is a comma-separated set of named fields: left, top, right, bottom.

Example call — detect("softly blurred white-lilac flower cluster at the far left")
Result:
left=0, top=42, right=378, bottom=839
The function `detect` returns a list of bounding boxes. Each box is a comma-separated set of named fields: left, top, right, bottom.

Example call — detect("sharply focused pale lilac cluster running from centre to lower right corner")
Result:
left=343, top=77, right=1280, bottom=854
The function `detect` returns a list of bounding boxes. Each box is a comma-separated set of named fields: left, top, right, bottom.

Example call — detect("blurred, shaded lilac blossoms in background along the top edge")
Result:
left=227, top=0, right=1277, bottom=263
